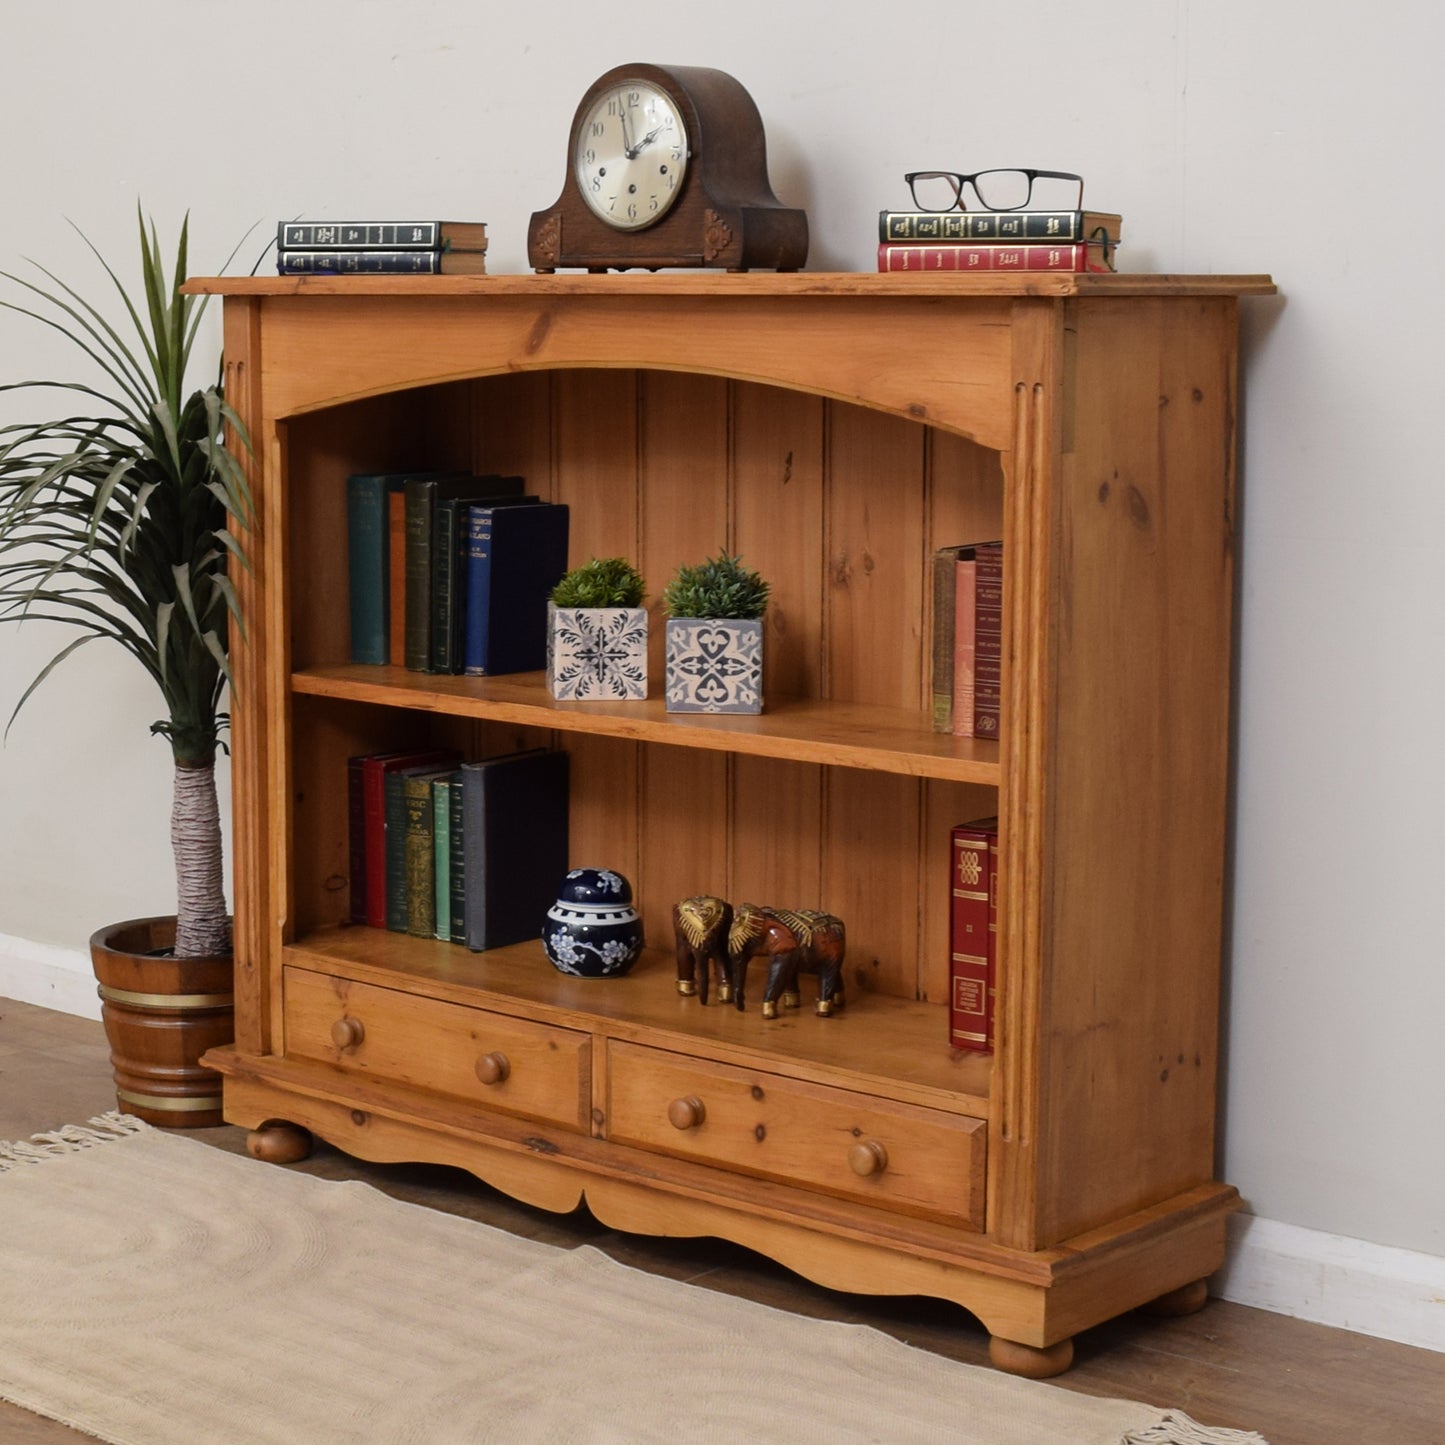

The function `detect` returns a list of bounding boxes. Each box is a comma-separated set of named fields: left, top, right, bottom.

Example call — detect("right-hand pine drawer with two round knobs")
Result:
left=607, top=1042, right=988, bottom=1230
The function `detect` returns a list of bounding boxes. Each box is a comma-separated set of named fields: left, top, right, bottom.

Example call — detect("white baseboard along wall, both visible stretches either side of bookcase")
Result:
left=0, top=933, right=1445, bottom=1351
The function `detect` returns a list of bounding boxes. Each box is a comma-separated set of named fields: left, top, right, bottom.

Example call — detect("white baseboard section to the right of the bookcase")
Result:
left=1209, top=1214, right=1445, bottom=1351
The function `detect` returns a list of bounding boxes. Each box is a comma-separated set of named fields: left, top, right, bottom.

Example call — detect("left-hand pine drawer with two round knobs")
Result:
left=285, top=968, right=591, bottom=1133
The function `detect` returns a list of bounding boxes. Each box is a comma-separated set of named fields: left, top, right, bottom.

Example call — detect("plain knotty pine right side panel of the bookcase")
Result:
left=1040, top=299, right=1235, bottom=1241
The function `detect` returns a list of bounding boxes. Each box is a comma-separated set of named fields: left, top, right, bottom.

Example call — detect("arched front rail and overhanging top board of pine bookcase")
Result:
left=185, top=273, right=1273, bottom=451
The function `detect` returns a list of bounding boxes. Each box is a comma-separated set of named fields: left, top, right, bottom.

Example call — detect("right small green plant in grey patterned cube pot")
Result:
left=662, top=551, right=769, bottom=712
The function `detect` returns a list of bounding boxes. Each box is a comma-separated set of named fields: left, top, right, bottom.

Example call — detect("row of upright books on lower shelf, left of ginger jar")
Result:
left=347, top=747, right=568, bottom=949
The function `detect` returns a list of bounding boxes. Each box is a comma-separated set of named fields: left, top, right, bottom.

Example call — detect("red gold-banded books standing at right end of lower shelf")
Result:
left=948, top=818, right=998, bottom=1053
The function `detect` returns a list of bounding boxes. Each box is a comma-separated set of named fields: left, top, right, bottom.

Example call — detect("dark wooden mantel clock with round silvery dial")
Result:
left=527, top=62, right=808, bottom=272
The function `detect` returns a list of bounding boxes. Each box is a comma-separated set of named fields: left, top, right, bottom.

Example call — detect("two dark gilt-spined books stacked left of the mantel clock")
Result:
left=276, top=221, right=487, bottom=276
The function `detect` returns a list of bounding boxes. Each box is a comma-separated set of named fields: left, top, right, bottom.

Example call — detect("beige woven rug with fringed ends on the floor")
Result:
left=0, top=1114, right=1261, bottom=1445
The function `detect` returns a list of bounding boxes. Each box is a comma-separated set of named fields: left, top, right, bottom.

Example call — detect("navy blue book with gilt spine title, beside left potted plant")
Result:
left=462, top=501, right=569, bottom=678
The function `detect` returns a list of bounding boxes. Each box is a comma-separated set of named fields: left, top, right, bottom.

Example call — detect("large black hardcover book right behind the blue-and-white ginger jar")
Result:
left=461, top=749, right=568, bottom=951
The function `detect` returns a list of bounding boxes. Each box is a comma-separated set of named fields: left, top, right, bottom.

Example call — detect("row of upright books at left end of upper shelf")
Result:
left=347, top=471, right=569, bottom=676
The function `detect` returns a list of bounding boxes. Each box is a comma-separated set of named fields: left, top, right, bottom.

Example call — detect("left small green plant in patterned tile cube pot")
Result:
left=546, top=556, right=647, bottom=702
